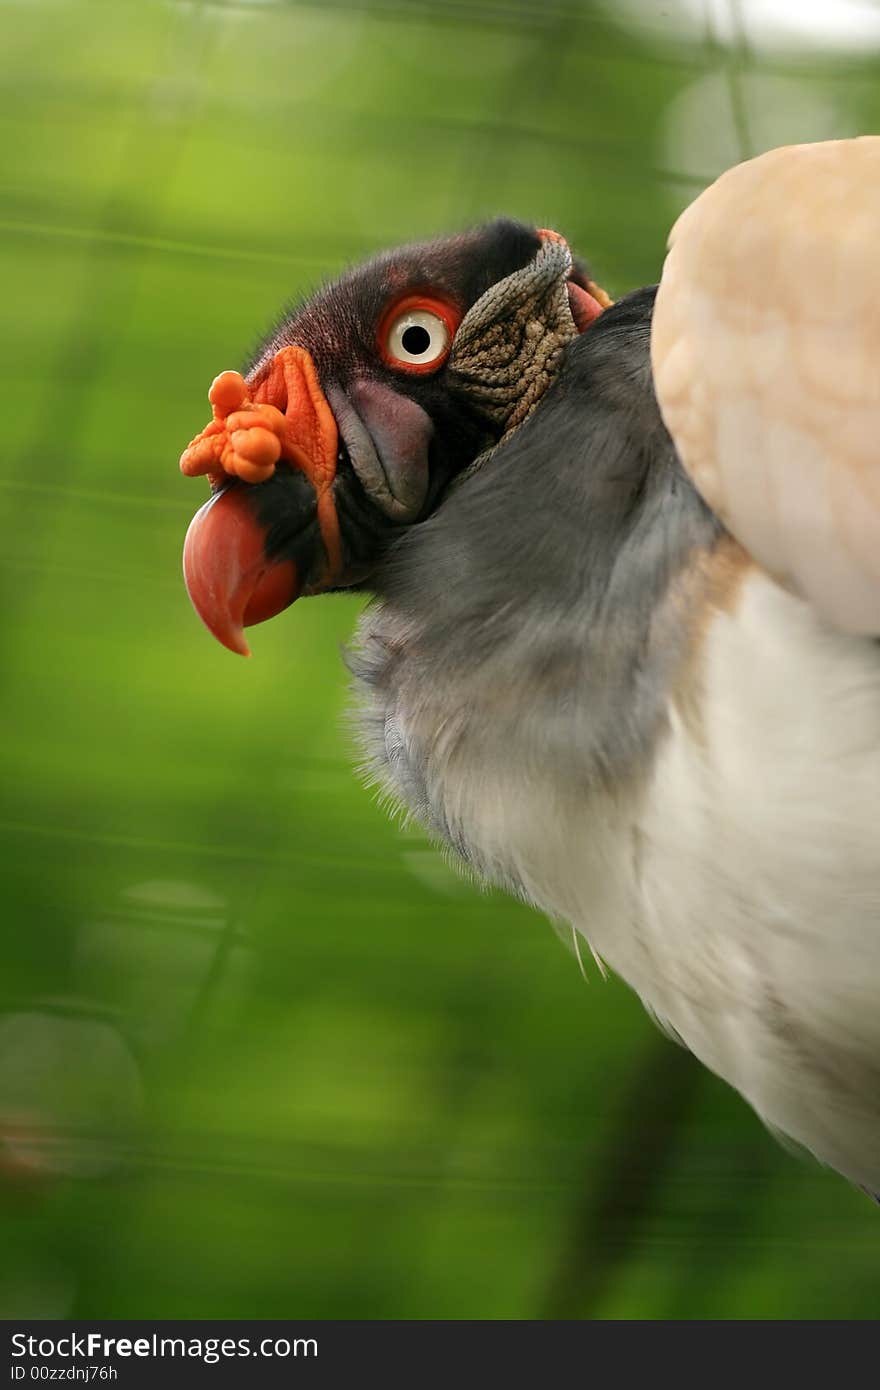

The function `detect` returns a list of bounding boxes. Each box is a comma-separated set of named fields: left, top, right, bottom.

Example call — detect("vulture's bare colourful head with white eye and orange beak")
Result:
left=181, top=220, right=610, bottom=655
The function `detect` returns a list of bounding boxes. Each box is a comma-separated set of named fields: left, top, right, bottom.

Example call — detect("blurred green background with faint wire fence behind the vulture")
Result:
left=0, top=0, right=880, bottom=1318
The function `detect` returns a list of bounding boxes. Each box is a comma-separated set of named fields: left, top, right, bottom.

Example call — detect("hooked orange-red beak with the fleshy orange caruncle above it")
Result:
left=181, top=348, right=341, bottom=656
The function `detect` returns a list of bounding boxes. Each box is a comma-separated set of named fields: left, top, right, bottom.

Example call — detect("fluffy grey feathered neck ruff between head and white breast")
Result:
left=350, top=291, right=719, bottom=897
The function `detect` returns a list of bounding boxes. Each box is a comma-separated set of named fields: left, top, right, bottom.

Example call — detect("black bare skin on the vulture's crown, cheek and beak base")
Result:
left=236, top=220, right=587, bottom=592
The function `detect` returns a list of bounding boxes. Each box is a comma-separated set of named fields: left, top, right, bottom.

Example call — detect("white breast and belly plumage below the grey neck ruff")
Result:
left=397, top=570, right=880, bottom=1190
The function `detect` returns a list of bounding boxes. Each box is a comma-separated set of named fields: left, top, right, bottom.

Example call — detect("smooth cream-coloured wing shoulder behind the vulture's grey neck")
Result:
left=652, top=136, right=880, bottom=634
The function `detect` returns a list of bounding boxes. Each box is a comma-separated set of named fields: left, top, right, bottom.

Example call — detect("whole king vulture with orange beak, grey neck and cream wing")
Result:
left=181, top=138, right=880, bottom=1193
